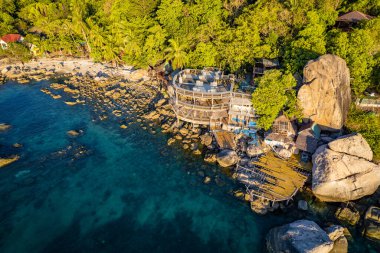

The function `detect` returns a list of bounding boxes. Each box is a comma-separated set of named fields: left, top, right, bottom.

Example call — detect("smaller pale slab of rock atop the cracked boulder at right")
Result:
left=328, top=134, right=373, bottom=161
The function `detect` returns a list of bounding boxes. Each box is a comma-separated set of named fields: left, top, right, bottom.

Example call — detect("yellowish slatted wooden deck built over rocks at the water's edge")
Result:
left=236, top=153, right=310, bottom=201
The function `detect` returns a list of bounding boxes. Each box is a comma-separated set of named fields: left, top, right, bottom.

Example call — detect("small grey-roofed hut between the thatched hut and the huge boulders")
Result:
left=296, top=124, right=321, bottom=154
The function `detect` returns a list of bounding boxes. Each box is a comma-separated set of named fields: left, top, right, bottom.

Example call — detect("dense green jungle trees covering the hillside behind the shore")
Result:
left=0, top=0, right=380, bottom=157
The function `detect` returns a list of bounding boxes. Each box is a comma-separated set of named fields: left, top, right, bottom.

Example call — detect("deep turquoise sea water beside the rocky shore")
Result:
left=0, top=82, right=378, bottom=253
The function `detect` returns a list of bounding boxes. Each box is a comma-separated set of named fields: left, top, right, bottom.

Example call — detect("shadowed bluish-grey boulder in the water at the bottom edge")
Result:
left=266, top=220, right=334, bottom=253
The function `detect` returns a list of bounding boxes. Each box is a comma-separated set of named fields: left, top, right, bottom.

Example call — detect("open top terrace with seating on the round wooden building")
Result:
left=173, top=69, right=235, bottom=93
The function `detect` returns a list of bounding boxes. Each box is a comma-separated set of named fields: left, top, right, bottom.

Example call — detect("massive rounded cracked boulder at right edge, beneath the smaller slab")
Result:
left=312, top=139, right=380, bottom=202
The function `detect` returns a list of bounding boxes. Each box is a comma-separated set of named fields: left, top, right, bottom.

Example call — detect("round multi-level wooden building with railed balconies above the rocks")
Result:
left=169, top=69, right=254, bottom=129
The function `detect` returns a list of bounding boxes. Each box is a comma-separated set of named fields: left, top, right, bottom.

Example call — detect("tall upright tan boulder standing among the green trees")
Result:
left=298, top=54, right=351, bottom=130
